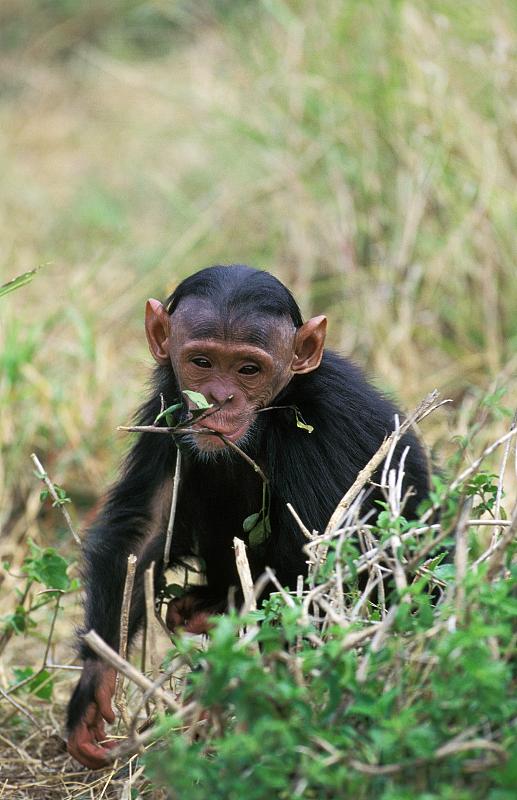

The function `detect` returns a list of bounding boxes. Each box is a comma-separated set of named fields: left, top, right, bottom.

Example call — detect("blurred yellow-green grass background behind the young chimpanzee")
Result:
left=0, top=0, right=517, bottom=552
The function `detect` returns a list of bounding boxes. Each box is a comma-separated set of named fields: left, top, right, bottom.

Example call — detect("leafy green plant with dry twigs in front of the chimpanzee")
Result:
left=145, top=428, right=517, bottom=800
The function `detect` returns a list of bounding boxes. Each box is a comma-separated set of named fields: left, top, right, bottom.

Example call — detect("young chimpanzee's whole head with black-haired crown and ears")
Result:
left=145, top=265, right=327, bottom=453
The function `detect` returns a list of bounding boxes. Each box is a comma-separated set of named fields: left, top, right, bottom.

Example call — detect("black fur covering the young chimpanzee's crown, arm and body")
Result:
left=68, top=266, right=429, bottom=729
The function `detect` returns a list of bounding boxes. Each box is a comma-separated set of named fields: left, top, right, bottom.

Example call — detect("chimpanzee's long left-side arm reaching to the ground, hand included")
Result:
left=68, top=400, right=175, bottom=767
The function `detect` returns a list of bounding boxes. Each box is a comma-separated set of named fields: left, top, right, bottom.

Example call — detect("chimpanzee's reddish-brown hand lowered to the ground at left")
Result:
left=67, top=659, right=116, bottom=769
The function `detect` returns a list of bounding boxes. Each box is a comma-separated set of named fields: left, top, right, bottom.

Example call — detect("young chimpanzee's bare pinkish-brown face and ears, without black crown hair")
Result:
left=146, top=298, right=327, bottom=452
